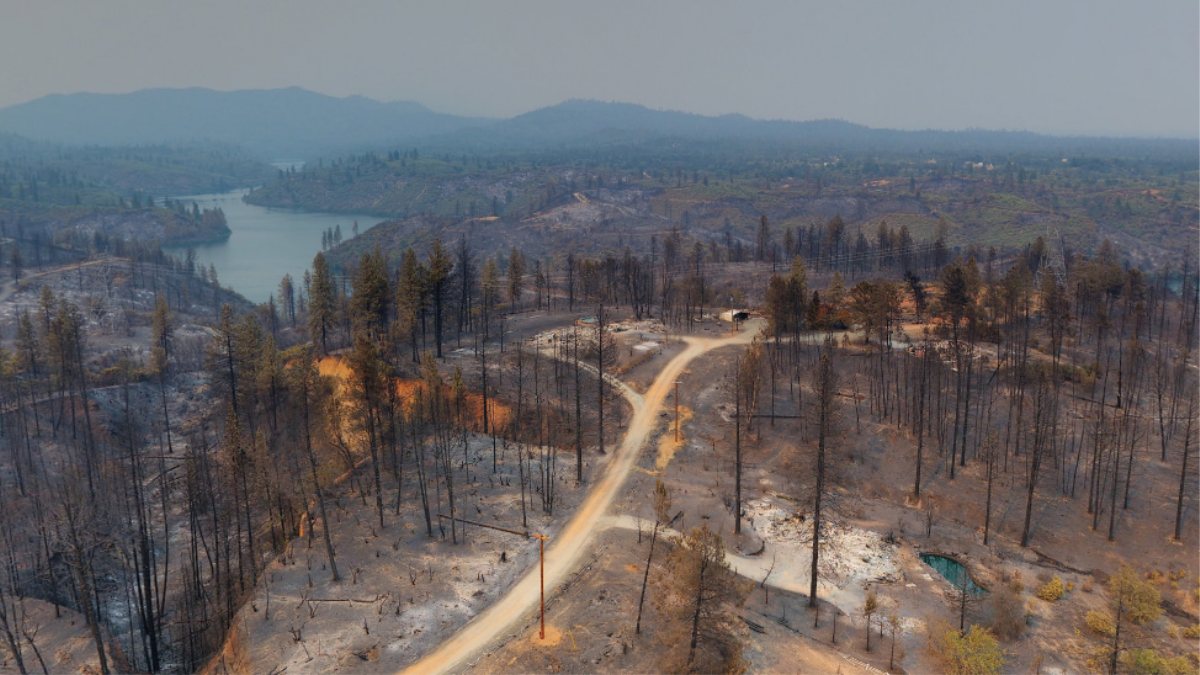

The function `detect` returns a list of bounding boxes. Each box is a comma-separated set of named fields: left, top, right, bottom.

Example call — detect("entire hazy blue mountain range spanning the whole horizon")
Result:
left=0, top=88, right=1200, bottom=160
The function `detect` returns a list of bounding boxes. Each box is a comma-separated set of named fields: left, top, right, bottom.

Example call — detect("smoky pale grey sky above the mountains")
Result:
left=0, top=0, right=1200, bottom=137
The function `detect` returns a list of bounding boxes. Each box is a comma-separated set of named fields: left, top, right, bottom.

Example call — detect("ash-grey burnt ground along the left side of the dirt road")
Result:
left=214, top=315, right=670, bottom=673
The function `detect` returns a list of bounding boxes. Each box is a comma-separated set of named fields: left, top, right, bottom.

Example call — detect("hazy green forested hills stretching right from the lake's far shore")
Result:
left=258, top=145, right=1200, bottom=265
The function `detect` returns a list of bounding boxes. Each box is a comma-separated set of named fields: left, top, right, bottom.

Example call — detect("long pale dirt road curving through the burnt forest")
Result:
left=401, top=322, right=762, bottom=675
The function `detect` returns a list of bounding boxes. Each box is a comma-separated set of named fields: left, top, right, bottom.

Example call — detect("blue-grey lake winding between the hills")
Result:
left=164, top=190, right=384, bottom=303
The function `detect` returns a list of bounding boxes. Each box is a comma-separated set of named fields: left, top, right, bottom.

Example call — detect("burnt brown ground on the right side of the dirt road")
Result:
left=472, top=319, right=1200, bottom=675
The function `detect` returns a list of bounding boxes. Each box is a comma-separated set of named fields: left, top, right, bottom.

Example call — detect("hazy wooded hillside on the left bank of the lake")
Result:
left=0, top=135, right=275, bottom=257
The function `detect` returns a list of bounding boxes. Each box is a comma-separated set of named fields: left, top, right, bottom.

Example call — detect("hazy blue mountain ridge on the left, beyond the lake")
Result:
left=0, top=86, right=491, bottom=159
